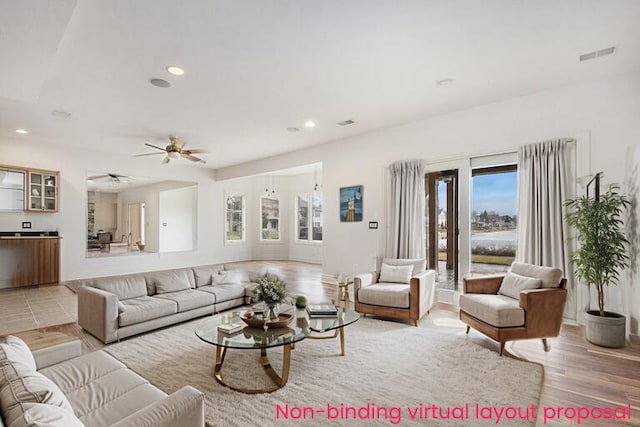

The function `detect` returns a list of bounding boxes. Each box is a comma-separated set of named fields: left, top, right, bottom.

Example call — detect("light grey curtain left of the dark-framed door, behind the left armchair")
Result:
left=387, top=160, right=426, bottom=258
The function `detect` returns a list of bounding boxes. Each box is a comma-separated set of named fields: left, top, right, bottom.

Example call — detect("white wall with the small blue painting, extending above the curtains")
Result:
left=216, top=72, right=640, bottom=334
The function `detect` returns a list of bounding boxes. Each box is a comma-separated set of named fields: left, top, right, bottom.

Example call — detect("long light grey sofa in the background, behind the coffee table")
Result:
left=78, top=264, right=255, bottom=344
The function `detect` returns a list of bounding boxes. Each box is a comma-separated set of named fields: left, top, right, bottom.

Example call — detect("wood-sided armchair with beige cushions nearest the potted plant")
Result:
left=460, top=263, right=567, bottom=356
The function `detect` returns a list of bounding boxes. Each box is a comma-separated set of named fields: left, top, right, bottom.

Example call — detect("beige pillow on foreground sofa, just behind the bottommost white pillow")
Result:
left=0, top=372, right=73, bottom=425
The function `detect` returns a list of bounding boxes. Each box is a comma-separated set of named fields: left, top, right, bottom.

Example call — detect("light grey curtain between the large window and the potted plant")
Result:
left=517, top=139, right=575, bottom=316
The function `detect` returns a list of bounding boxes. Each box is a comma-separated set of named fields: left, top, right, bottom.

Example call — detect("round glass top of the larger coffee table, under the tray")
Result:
left=195, top=312, right=308, bottom=349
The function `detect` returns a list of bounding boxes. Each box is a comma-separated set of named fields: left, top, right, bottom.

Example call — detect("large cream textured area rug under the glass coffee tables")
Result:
left=105, top=318, right=543, bottom=427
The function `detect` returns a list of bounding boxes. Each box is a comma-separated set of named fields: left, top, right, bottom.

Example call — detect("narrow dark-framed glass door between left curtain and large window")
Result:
left=425, top=169, right=459, bottom=290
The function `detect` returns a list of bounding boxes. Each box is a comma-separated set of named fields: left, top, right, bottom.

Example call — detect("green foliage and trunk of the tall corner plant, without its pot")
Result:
left=564, top=184, right=630, bottom=317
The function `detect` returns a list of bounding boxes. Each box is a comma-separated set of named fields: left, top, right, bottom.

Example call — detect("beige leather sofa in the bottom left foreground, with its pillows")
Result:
left=0, top=336, right=205, bottom=427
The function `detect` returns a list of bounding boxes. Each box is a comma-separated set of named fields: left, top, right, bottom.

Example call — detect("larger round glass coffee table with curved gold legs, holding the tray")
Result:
left=195, top=314, right=309, bottom=394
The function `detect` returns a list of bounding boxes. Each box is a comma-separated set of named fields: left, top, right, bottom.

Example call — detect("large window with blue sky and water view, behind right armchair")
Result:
left=471, top=164, right=518, bottom=271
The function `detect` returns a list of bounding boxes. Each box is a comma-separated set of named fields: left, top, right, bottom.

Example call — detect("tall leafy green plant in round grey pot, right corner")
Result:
left=565, top=174, right=630, bottom=347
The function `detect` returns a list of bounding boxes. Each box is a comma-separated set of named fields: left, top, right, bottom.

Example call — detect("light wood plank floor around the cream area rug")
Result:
left=0, top=261, right=640, bottom=427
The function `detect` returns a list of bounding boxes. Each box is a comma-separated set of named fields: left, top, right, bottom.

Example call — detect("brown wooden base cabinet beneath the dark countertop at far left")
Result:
left=0, top=237, right=60, bottom=288
